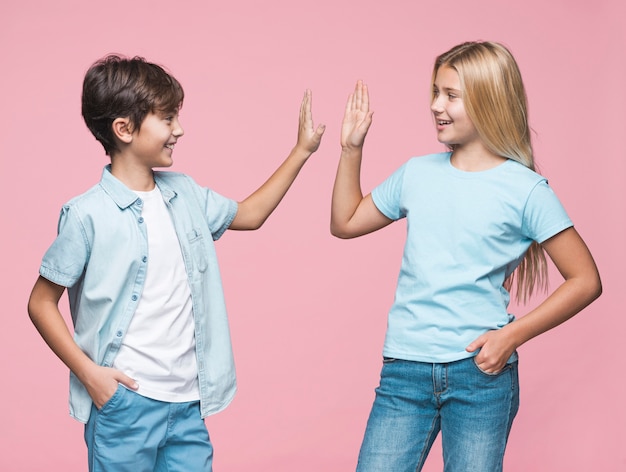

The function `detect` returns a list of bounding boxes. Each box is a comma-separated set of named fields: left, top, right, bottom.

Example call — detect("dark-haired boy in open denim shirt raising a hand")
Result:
left=28, top=56, right=324, bottom=472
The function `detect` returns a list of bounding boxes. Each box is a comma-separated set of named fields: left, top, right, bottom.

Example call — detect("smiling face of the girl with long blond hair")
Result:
left=430, top=66, right=482, bottom=151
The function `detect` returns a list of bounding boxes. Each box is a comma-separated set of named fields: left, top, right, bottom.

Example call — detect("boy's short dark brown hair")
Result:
left=82, top=54, right=185, bottom=156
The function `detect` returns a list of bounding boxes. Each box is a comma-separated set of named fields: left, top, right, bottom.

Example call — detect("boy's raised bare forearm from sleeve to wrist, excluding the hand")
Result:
left=230, top=145, right=312, bottom=230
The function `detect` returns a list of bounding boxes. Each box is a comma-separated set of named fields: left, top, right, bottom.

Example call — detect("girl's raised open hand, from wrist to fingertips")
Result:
left=341, top=80, right=374, bottom=149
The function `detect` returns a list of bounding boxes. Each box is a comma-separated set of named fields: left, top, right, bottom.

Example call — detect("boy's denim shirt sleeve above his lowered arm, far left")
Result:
left=39, top=205, right=89, bottom=287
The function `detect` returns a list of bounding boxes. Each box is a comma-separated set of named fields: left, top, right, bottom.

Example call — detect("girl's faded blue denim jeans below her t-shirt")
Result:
left=357, top=357, right=519, bottom=472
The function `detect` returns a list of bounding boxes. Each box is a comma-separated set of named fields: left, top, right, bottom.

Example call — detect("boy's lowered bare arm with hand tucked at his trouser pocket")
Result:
left=28, top=276, right=137, bottom=408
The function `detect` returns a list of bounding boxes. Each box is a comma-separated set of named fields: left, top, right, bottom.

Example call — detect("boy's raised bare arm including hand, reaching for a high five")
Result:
left=229, top=90, right=325, bottom=230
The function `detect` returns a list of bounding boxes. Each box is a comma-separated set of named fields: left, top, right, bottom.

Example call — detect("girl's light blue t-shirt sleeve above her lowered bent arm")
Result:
left=522, top=180, right=574, bottom=243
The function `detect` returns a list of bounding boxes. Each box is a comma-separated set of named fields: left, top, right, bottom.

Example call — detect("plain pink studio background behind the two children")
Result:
left=0, top=0, right=626, bottom=472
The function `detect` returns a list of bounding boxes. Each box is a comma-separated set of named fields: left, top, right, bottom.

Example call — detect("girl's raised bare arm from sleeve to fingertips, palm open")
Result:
left=330, top=80, right=392, bottom=238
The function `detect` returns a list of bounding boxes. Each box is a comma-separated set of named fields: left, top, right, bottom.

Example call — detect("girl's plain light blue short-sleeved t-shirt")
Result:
left=372, top=153, right=572, bottom=362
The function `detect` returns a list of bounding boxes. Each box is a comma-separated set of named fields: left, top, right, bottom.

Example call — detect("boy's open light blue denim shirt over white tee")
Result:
left=39, top=166, right=237, bottom=423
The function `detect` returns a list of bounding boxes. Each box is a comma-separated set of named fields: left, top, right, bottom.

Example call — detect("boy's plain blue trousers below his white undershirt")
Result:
left=85, top=386, right=213, bottom=472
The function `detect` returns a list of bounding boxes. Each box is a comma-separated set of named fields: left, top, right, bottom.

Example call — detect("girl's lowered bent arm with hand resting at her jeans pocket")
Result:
left=467, top=227, right=602, bottom=373
